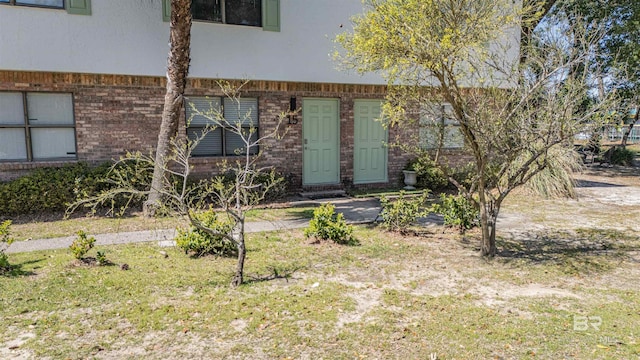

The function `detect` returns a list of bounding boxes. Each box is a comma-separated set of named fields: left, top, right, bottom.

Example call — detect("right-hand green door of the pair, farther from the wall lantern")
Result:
left=353, top=100, right=388, bottom=184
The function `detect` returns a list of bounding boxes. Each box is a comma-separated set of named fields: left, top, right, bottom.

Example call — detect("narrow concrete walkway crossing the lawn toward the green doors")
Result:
left=6, top=199, right=381, bottom=253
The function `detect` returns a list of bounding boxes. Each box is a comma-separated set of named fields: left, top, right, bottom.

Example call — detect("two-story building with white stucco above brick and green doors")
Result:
left=0, top=0, right=520, bottom=187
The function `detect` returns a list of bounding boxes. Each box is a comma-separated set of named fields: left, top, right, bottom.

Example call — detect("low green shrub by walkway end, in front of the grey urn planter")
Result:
left=380, top=190, right=429, bottom=232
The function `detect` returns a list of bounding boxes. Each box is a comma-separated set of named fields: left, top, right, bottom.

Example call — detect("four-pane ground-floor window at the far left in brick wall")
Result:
left=0, top=92, right=76, bottom=161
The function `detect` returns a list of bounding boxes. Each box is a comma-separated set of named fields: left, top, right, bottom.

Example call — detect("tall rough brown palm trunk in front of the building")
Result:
left=144, top=0, right=191, bottom=216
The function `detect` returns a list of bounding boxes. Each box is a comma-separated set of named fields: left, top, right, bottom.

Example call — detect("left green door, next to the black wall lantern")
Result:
left=302, top=99, right=340, bottom=185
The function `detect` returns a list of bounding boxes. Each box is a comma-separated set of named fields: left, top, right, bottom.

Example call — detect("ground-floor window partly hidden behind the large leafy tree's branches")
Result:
left=420, top=103, right=464, bottom=149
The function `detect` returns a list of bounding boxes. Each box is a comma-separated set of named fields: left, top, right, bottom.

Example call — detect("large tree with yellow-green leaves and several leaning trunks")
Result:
left=337, top=0, right=614, bottom=257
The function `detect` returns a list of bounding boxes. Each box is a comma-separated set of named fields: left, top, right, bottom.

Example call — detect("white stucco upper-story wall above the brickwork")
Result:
left=0, top=0, right=384, bottom=84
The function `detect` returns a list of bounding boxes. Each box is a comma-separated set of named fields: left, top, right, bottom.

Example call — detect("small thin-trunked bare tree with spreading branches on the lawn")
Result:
left=68, top=81, right=288, bottom=286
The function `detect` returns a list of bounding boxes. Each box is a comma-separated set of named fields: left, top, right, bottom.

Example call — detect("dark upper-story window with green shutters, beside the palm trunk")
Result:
left=191, top=0, right=262, bottom=27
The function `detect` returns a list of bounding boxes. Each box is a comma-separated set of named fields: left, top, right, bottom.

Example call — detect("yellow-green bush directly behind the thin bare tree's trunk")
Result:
left=176, top=209, right=237, bottom=257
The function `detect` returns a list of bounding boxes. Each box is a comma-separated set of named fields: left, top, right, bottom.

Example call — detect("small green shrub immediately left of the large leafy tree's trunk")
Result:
left=433, top=194, right=480, bottom=232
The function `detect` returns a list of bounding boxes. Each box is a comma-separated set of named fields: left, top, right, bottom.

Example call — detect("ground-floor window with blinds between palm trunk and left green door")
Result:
left=186, top=97, right=258, bottom=156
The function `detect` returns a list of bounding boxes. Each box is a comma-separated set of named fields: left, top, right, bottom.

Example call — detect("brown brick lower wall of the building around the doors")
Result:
left=0, top=71, right=410, bottom=187
